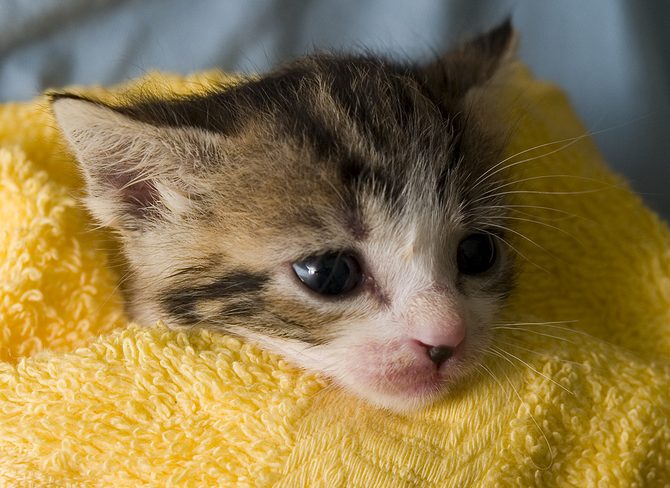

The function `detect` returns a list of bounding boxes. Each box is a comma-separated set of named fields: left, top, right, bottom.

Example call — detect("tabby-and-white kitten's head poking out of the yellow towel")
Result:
left=53, top=23, right=512, bottom=409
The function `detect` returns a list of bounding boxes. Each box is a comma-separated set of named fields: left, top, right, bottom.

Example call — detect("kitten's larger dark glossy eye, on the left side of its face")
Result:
left=292, top=252, right=362, bottom=295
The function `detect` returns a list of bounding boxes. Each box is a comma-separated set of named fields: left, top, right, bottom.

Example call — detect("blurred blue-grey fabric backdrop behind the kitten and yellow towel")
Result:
left=0, top=0, right=670, bottom=219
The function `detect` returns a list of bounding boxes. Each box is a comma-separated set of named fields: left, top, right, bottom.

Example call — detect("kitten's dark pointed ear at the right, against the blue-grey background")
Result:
left=417, top=18, right=517, bottom=107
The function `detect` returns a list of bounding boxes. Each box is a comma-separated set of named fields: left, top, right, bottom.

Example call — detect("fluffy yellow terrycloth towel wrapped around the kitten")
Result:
left=0, top=68, right=670, bottom=487
